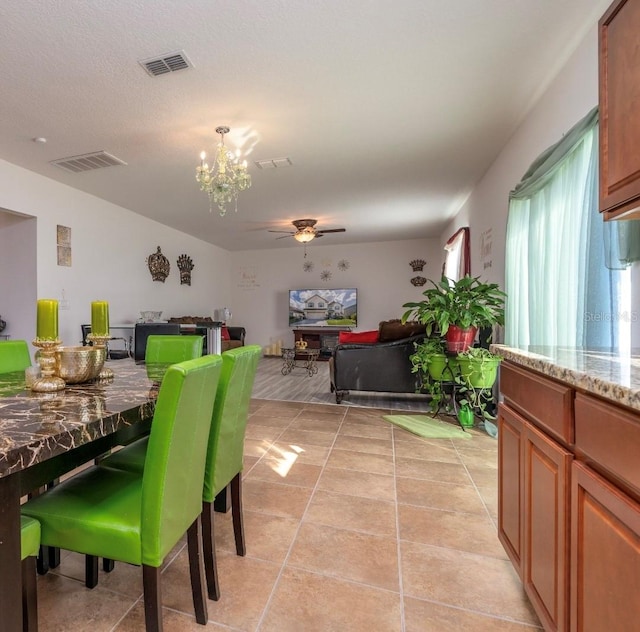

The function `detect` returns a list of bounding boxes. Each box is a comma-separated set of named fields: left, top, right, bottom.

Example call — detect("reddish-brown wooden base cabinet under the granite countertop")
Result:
left=498, top=361, right=640, bottom=632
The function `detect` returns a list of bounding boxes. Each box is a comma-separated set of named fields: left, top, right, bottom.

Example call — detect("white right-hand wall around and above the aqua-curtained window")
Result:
left=450, top=25, right=598, bottom=285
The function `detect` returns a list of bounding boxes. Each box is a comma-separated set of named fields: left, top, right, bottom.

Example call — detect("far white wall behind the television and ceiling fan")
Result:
left=228, top=239, right=444, bottom=346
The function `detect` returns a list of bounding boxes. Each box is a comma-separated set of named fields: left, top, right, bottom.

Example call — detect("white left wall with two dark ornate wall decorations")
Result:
left=0, top=161, right=231, bottom=345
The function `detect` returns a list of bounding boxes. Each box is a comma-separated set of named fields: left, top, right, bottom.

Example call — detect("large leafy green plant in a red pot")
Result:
left=402, top=276, right=506, bottom=352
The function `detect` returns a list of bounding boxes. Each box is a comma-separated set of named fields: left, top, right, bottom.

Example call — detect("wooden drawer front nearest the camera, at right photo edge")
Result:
left=575, top=393, right=640, bottom=496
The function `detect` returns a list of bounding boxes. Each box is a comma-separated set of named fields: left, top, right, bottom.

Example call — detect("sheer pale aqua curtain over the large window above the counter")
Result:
left=505, top=108, right=620, bottom=347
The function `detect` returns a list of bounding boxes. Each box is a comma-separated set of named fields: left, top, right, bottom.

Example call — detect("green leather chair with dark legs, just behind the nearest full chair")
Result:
left=101, top=345, right=262, bottom=601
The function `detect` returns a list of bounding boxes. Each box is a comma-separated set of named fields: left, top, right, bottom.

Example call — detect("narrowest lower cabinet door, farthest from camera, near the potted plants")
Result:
left=498, top=404, right=524, bottom=579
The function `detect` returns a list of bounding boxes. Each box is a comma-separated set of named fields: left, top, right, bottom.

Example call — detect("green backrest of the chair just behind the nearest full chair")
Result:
left=202, top=345, right=262, bottom=502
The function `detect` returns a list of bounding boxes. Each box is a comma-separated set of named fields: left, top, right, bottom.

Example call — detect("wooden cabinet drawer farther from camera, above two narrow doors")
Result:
left=500, top=362, right=574, bottom=445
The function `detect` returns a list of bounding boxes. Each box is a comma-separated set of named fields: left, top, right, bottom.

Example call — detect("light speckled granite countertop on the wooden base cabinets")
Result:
left=491, top=345, right=640, bottom=410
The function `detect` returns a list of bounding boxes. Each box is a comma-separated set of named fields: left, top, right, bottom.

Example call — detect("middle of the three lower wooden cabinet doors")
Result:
left=522, top=422, right=573, bottom=631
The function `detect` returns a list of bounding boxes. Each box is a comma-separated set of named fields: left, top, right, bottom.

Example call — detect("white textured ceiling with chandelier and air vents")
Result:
left=0, top=0, right=608, bottom=250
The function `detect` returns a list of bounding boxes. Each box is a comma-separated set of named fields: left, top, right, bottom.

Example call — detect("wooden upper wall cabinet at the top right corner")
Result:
left=598, top=0, right=640, bottom=219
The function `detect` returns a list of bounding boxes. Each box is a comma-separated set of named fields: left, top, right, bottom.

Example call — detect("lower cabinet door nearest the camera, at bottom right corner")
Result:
left=571, top=462, right=640, bottom=632
